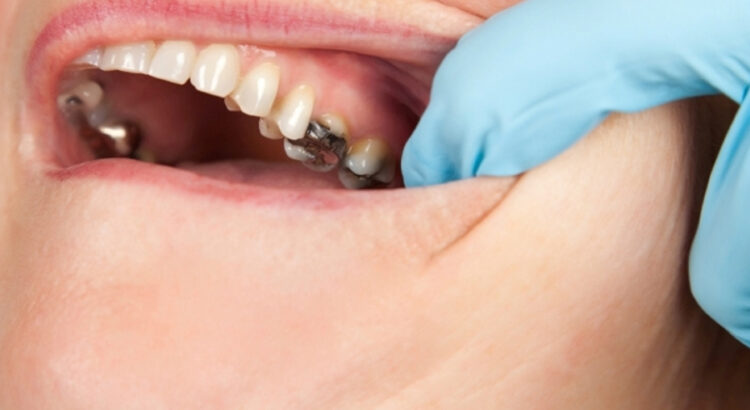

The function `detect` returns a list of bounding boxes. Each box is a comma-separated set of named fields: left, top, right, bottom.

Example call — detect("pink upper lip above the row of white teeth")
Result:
left=26, top=0, right=472, bottom=102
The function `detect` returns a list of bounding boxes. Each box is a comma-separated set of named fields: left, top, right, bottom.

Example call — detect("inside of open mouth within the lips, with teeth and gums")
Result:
left=57, top=41, right=421, bottom=189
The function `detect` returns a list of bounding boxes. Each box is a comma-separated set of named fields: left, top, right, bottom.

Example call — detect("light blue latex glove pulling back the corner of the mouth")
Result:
left=402, top=0, right=750, bottom=346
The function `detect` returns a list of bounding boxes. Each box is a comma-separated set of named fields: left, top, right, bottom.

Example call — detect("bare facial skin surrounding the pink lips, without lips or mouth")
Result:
left=0, top=0, right=750, bottom=409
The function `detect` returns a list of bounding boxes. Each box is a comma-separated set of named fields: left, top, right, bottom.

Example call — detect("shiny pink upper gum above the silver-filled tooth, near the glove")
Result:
left=238, top=46, right=424, bottom=152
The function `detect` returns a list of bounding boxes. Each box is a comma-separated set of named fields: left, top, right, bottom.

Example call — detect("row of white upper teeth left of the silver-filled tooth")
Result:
left=82, top=41, right=315, bottom=140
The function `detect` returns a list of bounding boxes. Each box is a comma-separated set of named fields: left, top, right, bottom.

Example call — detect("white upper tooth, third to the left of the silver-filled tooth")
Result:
left=190, top=44, right=240, bottom=98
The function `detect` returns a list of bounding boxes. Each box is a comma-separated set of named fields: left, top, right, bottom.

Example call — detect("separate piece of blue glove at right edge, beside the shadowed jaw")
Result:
left=690, top=98, right=750, bottom=347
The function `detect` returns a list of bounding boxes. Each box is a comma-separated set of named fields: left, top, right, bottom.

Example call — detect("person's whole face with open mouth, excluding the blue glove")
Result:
left=0, top=0, right=748, bottom=409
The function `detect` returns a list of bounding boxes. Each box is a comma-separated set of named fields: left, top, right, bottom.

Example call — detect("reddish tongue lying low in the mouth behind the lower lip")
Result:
left=177, top=160, right=342, bottom=190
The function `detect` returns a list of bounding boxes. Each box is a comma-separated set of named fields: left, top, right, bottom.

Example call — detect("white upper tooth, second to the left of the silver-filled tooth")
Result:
left=232, top=63, right=281, bottom=117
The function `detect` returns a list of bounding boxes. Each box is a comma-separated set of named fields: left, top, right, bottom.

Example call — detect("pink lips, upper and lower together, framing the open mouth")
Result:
left=25, top=0, right=464, bottom=209
